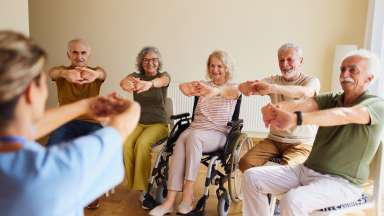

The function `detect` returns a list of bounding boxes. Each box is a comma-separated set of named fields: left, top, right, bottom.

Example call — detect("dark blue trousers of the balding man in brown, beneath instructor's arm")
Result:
left=47, top=120, right=103, bottom=146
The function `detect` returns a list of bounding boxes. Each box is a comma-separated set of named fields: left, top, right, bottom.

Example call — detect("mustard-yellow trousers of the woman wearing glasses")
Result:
left=124, top=124, right=168, bottom=190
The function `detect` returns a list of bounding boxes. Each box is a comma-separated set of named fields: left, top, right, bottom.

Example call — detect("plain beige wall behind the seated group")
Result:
left=30, top=0, right=368, bottom=105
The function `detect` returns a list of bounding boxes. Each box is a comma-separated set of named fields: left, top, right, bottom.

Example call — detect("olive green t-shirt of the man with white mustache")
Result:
left=304, top=92, right=384, bottom=185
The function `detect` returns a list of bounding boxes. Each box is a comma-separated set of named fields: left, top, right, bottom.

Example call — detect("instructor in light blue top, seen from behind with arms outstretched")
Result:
left=0, top=31, right=140, bottom=216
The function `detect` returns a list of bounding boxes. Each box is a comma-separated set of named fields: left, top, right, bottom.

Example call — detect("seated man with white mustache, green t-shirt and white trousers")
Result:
left=243, top=50, right=384, bottom=216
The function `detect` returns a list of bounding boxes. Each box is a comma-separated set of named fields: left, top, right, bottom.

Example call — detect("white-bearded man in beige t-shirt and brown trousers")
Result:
left=239, top=43, right=320, bottom=172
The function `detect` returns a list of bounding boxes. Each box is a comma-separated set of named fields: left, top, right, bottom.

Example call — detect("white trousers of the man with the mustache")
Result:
left=243, top=164, right=362, bottom=216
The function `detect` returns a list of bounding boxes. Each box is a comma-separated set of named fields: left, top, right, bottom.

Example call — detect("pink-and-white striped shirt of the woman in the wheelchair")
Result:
left=191, top=82, right=237, bottom=134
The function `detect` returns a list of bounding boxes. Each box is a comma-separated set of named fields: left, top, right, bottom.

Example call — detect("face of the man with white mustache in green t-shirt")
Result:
left=339, top=56, right=373, bottom=94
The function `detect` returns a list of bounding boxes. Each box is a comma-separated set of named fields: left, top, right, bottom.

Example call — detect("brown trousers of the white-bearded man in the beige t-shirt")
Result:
left=239, top=138, right=312, bottom=172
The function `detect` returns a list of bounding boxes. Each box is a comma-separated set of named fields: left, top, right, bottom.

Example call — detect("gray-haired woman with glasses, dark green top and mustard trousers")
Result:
left=120, top=47, right=171, bottom=204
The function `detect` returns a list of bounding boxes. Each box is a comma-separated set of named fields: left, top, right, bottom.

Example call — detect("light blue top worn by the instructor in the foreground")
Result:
left=0, top=127, right=124, bottom=216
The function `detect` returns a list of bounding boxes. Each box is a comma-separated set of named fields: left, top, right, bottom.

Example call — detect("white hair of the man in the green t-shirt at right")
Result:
left=341, top=49, right=381, bottom=76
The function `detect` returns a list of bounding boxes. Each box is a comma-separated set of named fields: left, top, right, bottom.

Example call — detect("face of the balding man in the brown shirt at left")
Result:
left=67, top=42, right=91, bottom=67
